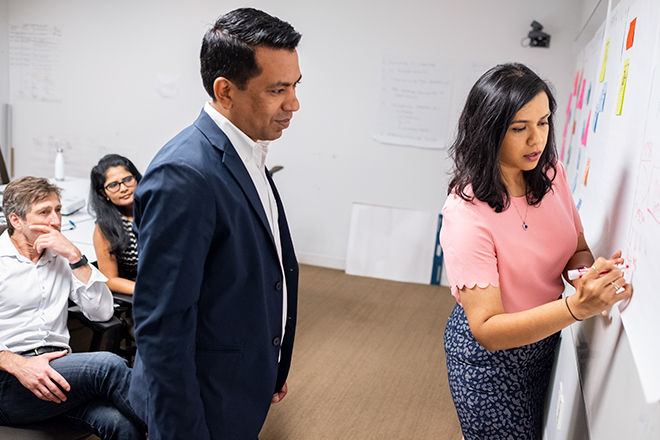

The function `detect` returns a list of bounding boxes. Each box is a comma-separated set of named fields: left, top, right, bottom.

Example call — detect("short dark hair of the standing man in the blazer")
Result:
left=199, top=8, right=301, bottom=96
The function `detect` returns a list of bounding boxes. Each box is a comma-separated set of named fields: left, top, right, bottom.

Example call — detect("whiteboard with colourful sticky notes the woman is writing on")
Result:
left=560, top=0, right=660, bottom=439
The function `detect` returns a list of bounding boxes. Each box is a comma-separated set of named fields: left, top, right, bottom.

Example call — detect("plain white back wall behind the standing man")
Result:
left=3, top=0, right=582, bottom=268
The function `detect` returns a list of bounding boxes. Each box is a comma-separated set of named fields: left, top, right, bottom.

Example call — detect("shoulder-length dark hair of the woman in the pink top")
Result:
left=449, top=63, right=557, bottom=212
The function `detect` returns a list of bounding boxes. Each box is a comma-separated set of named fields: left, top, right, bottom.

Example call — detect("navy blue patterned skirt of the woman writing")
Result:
left=445, top=304, right=559, bottom=440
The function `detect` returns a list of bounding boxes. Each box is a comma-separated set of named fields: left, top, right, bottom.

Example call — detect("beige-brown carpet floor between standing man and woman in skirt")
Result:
left=259, top=265, right=461, bottom=440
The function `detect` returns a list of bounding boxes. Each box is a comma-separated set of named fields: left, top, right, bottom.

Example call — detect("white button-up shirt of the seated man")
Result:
left=0, top=231, right=114, bottom=353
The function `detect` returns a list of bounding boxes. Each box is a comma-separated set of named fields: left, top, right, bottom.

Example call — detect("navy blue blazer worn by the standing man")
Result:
left=129, top=110, right=298, bottom=440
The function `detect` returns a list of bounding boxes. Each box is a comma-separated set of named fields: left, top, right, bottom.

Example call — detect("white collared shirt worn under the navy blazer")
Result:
left=204, top=102, right=287, bottom=350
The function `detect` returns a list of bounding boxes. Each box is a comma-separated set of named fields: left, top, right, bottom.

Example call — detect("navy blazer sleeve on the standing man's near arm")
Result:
left=133, top=163, right=215, bottom=440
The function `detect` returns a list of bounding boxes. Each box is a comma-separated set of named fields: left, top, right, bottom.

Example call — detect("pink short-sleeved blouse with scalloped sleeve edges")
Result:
left=440, top=162, right=583, bottom=313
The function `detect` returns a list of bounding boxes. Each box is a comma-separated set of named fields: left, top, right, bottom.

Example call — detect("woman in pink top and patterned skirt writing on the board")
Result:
left=440, top=64, right=632, bottom=440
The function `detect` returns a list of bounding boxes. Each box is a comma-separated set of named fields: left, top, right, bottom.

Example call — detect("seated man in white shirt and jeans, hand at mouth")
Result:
left=0, top=177, right=145, bottom=439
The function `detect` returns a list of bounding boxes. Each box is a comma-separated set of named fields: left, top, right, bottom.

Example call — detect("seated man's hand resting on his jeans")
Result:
left=9, top=350, right=71, bottom=403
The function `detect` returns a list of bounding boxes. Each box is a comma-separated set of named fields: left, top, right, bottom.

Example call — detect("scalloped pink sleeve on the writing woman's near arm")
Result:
left=440, top=193, right=499, bottom=304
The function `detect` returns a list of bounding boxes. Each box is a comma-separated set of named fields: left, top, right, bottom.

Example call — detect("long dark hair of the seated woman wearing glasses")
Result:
left=89, top=154, right=142, bottom=255
